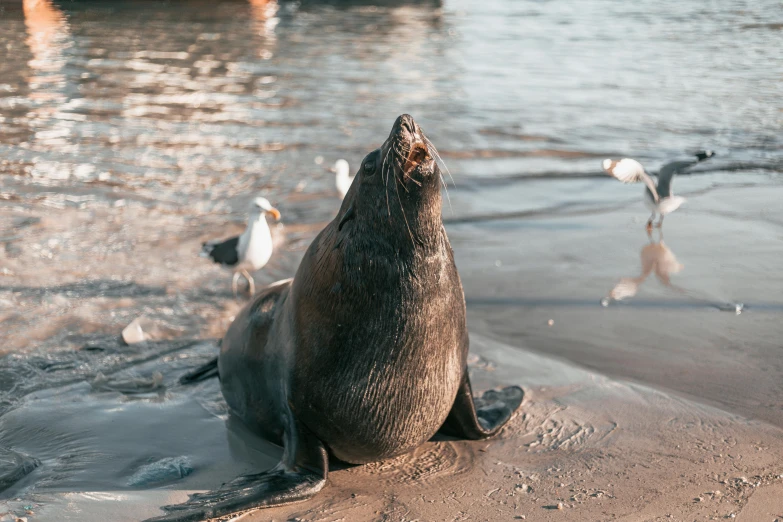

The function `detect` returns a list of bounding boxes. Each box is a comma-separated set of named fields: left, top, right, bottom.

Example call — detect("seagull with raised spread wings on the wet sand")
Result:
left=602, top=150, right=715, bottom=226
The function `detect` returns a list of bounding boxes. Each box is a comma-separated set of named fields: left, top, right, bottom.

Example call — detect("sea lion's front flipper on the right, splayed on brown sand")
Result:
left=440, top=369, right=525, bottom=440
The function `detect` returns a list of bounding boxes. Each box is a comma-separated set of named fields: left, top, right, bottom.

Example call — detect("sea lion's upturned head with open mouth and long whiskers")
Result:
left=339, top=114, right=442, bottom=247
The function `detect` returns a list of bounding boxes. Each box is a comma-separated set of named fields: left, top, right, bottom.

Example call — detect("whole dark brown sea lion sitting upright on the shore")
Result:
left=151, top=114, right=523, bottom=521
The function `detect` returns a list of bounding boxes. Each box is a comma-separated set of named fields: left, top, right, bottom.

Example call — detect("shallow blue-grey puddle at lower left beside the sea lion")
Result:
left=0, top=343, right=280, bottom=520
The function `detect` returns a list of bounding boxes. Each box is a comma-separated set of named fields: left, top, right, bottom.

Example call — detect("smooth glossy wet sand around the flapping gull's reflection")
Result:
left=451, top=181, right=783, bottom=427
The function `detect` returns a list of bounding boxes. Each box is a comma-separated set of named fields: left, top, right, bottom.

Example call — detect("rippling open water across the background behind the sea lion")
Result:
left=0, top=1, right=783, bottom=213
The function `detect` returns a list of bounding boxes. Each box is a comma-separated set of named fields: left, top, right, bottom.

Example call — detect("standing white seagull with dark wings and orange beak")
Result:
left=199, top=197, right=280, bottom=297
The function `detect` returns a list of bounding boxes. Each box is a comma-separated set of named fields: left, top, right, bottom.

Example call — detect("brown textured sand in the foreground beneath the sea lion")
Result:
left=10, top=335, right=783, bottom=521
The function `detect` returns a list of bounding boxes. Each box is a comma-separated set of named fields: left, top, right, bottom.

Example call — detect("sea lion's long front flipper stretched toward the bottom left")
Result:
left=145, top=422, right=329, bottom=522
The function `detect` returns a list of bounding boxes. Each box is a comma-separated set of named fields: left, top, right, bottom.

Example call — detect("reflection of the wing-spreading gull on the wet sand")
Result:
left=601, top=230, right=744, bottom=315
